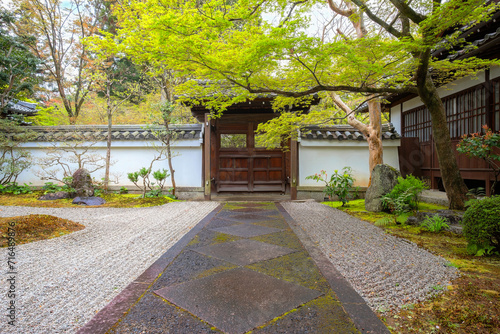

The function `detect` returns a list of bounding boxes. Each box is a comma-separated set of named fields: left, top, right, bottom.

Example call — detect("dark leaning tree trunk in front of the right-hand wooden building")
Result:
left=417, top=73, right=468, bottom=210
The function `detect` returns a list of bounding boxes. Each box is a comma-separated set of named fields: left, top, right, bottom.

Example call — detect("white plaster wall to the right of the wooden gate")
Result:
left=298, top=139, right=400, bottom=187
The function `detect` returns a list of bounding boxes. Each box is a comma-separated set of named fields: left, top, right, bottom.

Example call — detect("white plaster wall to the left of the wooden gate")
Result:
left=17, top=139, right=203, bottom=189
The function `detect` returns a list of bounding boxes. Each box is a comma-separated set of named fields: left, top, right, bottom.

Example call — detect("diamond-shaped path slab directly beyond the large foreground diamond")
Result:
left=193, top=239, right=297, bottom=266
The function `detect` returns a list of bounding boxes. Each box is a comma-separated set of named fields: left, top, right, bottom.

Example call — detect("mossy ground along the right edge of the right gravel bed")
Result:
left=325, top=200, right=500, bottom=334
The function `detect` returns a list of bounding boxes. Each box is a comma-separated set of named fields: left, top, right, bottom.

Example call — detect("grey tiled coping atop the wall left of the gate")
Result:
left=29, top=124, right=202, bottom=141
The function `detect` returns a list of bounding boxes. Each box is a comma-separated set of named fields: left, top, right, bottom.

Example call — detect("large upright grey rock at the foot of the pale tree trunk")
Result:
left=365, top=165, right=401, bottom=212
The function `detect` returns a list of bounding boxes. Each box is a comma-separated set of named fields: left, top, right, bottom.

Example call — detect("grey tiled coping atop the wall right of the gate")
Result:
left=300, top=123, right=401, bottom=141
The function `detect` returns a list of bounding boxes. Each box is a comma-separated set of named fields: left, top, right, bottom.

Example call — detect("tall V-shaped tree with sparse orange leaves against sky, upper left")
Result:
left=13, top=0, right=102, bottom=124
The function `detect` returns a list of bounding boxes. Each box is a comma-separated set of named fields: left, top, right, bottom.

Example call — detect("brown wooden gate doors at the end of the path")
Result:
left=215, top=122, right=286, bottom=192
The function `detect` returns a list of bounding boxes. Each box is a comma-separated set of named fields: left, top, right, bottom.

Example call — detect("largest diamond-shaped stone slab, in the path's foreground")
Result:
left=155, top=268, right=322, bottom=334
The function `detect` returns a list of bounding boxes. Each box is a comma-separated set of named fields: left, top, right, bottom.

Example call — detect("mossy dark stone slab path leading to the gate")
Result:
left=78, top=203, right=389, bottom=334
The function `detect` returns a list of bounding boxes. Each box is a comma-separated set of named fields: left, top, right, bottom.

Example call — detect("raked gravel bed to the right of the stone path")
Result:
left=281, top=202, right=458, bottom=310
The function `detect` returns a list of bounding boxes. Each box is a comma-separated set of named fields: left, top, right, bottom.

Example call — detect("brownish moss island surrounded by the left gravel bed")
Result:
left=0, top=215, right=85, bottom=247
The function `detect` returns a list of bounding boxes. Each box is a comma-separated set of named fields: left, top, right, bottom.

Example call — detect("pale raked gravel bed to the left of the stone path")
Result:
left=0, top=202, right=218, bottom=334
